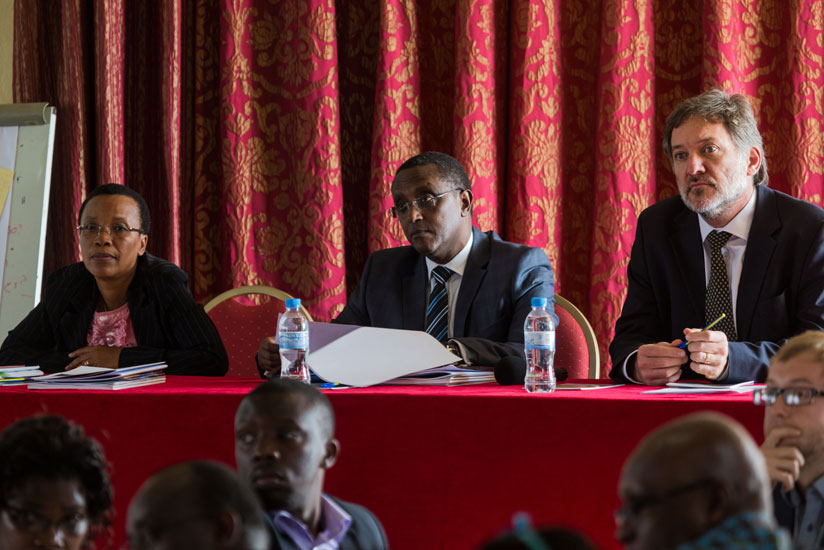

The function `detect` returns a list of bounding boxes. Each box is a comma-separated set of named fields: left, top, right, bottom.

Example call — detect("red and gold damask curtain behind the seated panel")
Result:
left=14, top=0, right=824, bottom=376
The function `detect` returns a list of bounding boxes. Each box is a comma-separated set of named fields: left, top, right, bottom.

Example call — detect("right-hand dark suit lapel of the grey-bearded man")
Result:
left=735, top=185, right=781, bottom=340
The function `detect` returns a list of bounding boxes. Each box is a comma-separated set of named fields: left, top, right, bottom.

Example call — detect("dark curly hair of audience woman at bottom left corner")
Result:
left=0, top=415, right=113, bottom=540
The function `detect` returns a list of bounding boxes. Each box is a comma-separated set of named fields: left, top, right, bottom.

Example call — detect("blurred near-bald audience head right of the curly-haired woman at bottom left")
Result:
left=126, top=461, right=269, bottom=550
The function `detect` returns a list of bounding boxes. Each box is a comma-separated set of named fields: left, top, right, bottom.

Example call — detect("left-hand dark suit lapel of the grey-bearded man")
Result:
left=669, top=207, right=707, bottom=320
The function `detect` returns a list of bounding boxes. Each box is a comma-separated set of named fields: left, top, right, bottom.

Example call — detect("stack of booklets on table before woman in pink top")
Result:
left=29, top=363, right=166, bottom=390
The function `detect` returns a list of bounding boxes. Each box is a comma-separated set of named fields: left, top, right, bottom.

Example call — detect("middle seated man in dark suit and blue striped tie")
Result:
left=258, top=152, right=555, bottom=371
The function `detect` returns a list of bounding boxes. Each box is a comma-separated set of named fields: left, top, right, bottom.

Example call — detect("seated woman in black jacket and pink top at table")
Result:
left=0, top=183, right=229, bottom=376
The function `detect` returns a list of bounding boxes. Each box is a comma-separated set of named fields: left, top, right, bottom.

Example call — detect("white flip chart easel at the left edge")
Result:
left=0, top=103, right=57, bottom=341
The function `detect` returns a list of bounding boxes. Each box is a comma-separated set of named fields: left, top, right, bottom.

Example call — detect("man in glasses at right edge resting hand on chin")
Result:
left=754, top=331, right=824, bottom=550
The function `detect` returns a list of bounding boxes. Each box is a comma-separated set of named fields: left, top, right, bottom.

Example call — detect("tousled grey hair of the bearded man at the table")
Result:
left=663, top=88, right=770, bottom=185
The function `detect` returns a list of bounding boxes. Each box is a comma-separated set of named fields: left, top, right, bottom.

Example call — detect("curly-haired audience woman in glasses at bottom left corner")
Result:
left=0, top=416, right=112, bottom=550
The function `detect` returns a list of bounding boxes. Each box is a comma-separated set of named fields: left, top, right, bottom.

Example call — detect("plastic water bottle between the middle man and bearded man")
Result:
left=524, top=298, right=555, bottom=393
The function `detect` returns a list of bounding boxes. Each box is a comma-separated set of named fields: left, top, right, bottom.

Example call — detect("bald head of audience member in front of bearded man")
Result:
left=616, top=413, right=772, bottom=549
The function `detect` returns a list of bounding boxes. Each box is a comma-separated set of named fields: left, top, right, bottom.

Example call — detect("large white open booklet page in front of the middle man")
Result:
left=309, top=322, right=461, bottom=387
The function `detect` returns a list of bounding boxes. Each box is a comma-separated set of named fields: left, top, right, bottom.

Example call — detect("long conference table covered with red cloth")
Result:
left=0, top=376, right=763, bottom=550
